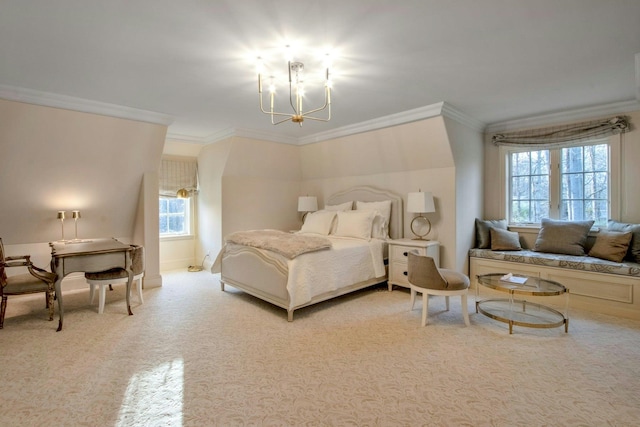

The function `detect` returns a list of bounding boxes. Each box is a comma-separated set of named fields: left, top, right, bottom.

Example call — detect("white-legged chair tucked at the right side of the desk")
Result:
left=84, top=245, right=144, bottom=314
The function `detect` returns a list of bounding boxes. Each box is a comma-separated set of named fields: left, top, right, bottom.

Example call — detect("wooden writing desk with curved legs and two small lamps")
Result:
left=49, top=239, right=133, bottom=331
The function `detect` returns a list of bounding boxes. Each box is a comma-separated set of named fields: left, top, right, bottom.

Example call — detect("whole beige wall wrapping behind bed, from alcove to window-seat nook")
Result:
left=198, top=117, right=482, bottom=270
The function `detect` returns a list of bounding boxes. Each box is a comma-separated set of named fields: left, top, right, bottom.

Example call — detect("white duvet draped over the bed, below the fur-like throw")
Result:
left=284, top=236, right=387, bottom=309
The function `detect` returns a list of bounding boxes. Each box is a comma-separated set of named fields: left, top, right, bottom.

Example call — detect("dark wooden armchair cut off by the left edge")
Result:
left=0, top=239, right=56, bottom=329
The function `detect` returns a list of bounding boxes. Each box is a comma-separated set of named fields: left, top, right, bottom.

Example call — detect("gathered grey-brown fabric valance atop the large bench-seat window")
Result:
left=492, top=116, right=630, bottom=148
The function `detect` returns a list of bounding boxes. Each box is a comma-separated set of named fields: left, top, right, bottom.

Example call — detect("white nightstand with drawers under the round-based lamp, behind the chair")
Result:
left=387, top=239, right=440, bottom=291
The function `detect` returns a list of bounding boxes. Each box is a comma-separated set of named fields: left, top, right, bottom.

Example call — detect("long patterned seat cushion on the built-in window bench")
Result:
left=469, top=249, right=640, bottom=278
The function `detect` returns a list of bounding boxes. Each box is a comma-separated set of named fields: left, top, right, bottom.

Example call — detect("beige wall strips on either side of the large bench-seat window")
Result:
left=483, top=111, right=640, bottom=224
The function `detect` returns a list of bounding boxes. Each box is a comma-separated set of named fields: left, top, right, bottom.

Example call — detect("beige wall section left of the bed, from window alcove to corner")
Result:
left=198, top=137, right=301, bottom=265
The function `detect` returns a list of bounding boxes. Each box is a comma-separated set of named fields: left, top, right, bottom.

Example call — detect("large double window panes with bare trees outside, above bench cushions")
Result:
left=507, top=141, right=611, bottom=226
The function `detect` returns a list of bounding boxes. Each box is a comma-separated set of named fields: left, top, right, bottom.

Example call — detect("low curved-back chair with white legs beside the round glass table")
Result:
left=408, top=252, right=469, bottom=326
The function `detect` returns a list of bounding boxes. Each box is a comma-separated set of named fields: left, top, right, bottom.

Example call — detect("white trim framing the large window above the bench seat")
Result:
left=498, top=134, right=622, bottom=228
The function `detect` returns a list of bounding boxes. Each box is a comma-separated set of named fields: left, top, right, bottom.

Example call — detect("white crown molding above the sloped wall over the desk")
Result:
left=0, top=84, right=174, bottom=126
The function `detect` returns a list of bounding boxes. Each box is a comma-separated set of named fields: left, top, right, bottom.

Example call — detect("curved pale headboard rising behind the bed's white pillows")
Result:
left=326, top=186, right=404, bottom=239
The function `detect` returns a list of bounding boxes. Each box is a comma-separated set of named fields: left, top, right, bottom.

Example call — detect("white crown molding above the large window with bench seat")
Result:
left=485, top=100, right=640, bottom=133
